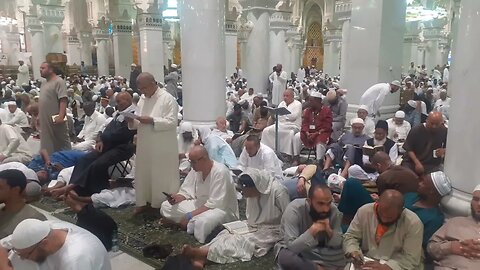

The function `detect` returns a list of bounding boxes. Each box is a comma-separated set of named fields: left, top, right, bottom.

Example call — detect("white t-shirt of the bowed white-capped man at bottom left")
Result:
left=40, top=221, right=112, bottom=270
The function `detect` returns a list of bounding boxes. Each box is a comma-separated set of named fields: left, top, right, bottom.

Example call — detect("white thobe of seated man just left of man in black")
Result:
left=72, top=111, right=107, bottom=151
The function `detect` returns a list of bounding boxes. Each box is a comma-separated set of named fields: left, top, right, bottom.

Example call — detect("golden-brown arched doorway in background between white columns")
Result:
left=303, top=22, right=323, bottom=69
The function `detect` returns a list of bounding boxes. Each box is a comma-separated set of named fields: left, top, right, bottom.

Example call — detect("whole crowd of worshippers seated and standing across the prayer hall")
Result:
left=0, top=60, right=474, bottom=270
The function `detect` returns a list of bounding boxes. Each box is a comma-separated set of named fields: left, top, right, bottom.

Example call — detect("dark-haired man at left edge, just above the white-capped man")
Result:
left=0, top=169, right=46, bottom=238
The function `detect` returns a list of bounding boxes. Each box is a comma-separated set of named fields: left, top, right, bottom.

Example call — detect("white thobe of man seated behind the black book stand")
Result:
left=262, top=100, right=302, bottom=156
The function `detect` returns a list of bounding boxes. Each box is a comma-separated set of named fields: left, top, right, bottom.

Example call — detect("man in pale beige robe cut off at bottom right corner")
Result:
left=427, top=185, right=480, bottom=270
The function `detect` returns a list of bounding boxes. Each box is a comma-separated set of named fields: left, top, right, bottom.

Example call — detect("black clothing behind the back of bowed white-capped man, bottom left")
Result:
left=77, top=204, right=117, bottom=251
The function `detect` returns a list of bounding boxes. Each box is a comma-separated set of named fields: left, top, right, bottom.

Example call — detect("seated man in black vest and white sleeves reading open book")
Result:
left=344, top=120, right=398, bottom=181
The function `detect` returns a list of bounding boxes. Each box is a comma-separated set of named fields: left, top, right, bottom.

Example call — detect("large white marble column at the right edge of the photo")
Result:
left=442, top=0, right=480, bottom=215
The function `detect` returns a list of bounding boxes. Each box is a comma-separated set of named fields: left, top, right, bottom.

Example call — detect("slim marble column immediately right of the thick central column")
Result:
left=225, top=13, right=238, bottom=77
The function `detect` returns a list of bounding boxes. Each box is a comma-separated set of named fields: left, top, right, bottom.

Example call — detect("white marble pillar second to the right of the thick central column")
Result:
left=246, top=9, right=273, bottom=94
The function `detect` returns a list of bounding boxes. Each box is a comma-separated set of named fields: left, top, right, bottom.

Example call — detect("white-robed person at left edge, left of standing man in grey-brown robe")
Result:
left=0, top=120, right=32, bottom=164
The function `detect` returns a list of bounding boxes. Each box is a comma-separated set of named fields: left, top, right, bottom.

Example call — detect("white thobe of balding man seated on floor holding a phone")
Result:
left=160, top=161, right=239, bottom=243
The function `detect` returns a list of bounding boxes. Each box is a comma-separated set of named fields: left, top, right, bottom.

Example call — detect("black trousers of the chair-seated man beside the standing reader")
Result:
left=70, top=144, right=135, bottom=196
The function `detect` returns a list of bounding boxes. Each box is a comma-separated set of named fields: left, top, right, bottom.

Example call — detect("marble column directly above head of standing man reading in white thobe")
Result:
left=137, top=10, right=164, bottom=82
